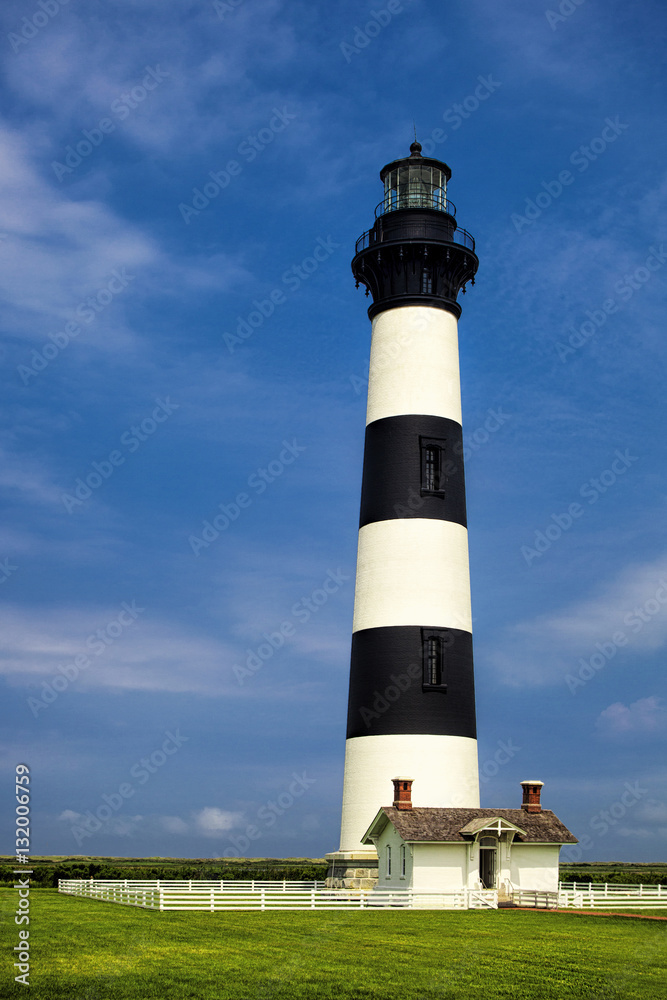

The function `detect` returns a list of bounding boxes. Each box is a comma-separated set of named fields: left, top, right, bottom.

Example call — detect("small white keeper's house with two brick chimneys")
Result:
left=363, top=778, right=578, bottom=892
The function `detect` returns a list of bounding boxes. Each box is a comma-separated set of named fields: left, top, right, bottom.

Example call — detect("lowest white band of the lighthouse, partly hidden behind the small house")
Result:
left=340, top=736, right=479, bottom=851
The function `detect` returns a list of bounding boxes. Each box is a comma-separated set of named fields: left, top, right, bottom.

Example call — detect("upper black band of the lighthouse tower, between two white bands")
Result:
left=359, top=413, right=466, bottom=527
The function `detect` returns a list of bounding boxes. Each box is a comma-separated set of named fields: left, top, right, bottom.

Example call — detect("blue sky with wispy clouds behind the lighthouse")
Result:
left=0, top=0, right=667, bottom=861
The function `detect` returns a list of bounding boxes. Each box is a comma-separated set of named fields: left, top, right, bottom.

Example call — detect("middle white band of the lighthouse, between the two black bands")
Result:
left=352, top=517, right=472, bottom=632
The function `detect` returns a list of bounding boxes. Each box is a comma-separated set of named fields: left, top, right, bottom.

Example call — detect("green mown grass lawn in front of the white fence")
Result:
left=0, top=889, right=667, bottom=1000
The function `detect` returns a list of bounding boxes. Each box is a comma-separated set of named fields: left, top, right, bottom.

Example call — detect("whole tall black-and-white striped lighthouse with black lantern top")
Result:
left=328, top=142, right=479, bottom=886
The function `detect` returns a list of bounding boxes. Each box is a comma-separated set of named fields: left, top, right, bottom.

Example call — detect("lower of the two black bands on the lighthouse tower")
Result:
left=347, top=625, right=476, bottom=739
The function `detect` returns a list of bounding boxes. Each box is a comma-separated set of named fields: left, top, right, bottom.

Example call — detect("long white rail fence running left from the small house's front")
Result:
left=58, top=879, right=498, bottom=912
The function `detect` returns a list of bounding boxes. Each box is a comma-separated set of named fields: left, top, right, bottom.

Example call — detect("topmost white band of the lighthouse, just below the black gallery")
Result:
left=366, top=306, right=461, bottom=424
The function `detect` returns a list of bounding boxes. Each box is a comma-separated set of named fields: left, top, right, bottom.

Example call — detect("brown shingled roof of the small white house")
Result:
left=366, top=806, right=579, bottom=844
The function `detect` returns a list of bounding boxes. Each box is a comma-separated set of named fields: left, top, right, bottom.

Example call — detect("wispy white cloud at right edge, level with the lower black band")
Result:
left=484, top=556, right=667, bottom=686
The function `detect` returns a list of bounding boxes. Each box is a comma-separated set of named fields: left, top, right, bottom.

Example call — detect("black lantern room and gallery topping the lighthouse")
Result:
left=352, top=141, right=479, bottom=319
